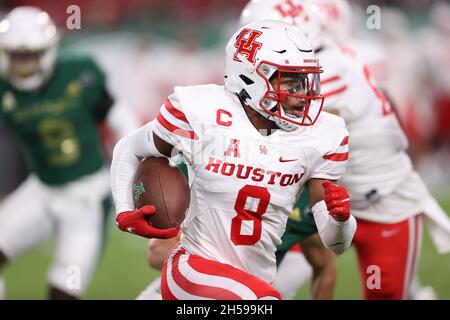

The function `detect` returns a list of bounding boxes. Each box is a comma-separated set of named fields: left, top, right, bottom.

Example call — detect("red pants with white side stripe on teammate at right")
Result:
left=353, top=216, right=421, bottom=300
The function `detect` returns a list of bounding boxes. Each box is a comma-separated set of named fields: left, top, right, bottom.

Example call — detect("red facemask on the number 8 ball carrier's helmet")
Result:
left=257, top=61, right=323, bottom=131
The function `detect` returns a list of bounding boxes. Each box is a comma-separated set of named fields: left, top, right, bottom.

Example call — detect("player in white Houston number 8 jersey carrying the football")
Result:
left=111, top=21, right=356, bottom=299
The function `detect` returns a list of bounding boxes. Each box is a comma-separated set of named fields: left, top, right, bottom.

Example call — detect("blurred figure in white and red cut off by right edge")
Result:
left=417, top=1, right=450, bottom=190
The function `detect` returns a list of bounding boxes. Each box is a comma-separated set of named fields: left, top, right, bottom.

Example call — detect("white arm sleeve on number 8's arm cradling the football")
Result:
left=111, top=125, right=161, bottom=213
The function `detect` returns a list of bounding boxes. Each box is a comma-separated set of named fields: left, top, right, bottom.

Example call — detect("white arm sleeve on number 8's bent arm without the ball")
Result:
left=311, top=200, right=356, bottom=254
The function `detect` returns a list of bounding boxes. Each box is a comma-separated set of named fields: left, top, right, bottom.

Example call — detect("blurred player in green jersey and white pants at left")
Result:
left=0, top=7, right=137, bottom=299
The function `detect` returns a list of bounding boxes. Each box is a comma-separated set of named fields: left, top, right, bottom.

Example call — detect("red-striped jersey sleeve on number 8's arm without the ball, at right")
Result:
left=311, top=120, right=349, bottom=180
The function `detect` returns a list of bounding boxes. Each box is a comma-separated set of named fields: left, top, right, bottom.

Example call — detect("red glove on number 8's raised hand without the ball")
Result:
left=322, top=181, right=350, bottom=221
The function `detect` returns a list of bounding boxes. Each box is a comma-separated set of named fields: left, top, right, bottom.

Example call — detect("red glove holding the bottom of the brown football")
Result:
left=116, top=206, right=180, bottom=239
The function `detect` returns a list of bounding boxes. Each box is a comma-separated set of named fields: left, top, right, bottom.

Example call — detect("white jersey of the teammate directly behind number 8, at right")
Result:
left=317, top=46, right=416, bottom=221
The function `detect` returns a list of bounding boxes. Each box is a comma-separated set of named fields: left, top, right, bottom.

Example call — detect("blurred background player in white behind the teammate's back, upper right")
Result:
left=364, top=7, right=433, bottom=165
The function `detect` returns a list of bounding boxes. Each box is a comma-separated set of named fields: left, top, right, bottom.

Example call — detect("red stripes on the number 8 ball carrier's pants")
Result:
left=161, top=247, right=281, bottom=300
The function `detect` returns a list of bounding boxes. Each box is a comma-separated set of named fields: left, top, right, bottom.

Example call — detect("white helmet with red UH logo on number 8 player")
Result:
left=225, top=20, right=323, bottom=131
